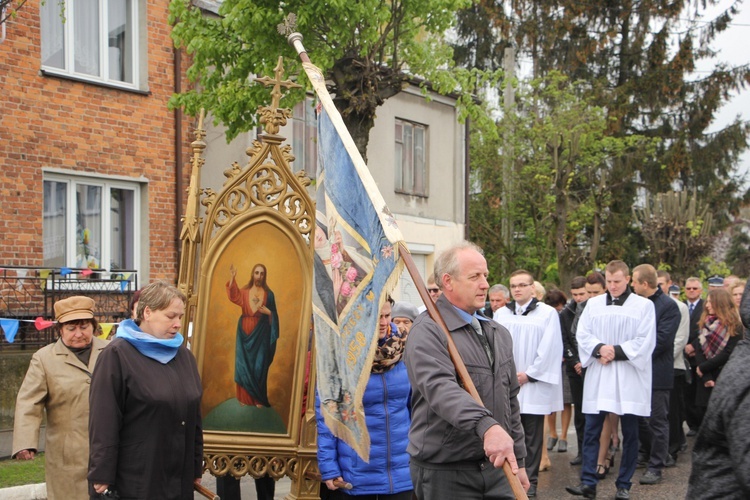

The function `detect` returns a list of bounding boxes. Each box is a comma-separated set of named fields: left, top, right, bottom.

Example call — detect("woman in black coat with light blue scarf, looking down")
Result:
left=88, top=281, right=203, bottom=500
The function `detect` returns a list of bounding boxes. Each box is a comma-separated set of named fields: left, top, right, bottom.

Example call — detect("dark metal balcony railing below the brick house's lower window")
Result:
left=0, top=266, right=138, bottom=351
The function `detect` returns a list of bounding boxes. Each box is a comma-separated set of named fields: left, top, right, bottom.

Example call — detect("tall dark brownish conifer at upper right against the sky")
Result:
left=455, top=0, right=750, bottom=270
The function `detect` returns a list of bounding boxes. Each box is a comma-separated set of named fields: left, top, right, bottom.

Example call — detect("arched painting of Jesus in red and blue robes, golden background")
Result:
left=200, top=217, right=310, bottom=435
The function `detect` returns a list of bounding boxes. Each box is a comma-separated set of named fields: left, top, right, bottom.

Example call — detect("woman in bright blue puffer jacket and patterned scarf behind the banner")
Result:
left=315, top=299, right=413, bottom=500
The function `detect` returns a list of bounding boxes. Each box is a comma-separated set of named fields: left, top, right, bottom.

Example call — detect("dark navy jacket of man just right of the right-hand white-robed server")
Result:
left=649, top=287, right=680, bottom=390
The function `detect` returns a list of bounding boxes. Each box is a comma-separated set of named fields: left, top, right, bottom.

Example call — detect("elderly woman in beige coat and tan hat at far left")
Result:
left=13, top=296, right=107, bottom=500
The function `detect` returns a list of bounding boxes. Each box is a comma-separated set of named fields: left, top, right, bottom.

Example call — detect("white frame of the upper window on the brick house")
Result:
left=40, top=0, right=146, bottom=90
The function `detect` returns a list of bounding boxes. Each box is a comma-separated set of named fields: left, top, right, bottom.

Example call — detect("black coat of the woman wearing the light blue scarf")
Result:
left=88, top=338, right=203, bottom=500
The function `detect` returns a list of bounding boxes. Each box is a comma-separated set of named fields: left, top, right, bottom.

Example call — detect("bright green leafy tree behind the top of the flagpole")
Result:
left=170, top=0, right=496, bottom=158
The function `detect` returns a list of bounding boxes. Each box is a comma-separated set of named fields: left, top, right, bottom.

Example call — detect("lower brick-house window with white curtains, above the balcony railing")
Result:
left=42, top=173, right=140, bottom=272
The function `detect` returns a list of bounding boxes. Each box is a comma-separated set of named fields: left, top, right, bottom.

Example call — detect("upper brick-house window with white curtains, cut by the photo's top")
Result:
left=41, top=0, right=139, bottom=87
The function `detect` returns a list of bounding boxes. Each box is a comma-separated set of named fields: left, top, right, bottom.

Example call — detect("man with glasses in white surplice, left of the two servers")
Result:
left=494, top=269, right=563, bottom=497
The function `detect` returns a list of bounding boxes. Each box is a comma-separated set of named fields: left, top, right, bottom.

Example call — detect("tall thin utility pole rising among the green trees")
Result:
left=500, top=46, right=516, bottom=275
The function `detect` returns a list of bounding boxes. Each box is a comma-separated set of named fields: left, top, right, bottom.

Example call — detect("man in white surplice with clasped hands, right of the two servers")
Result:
left=566, top=260, right=656, bottom=500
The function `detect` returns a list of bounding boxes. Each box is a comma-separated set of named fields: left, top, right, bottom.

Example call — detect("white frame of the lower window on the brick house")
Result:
left=42, top=172, right=142, bottom=275
